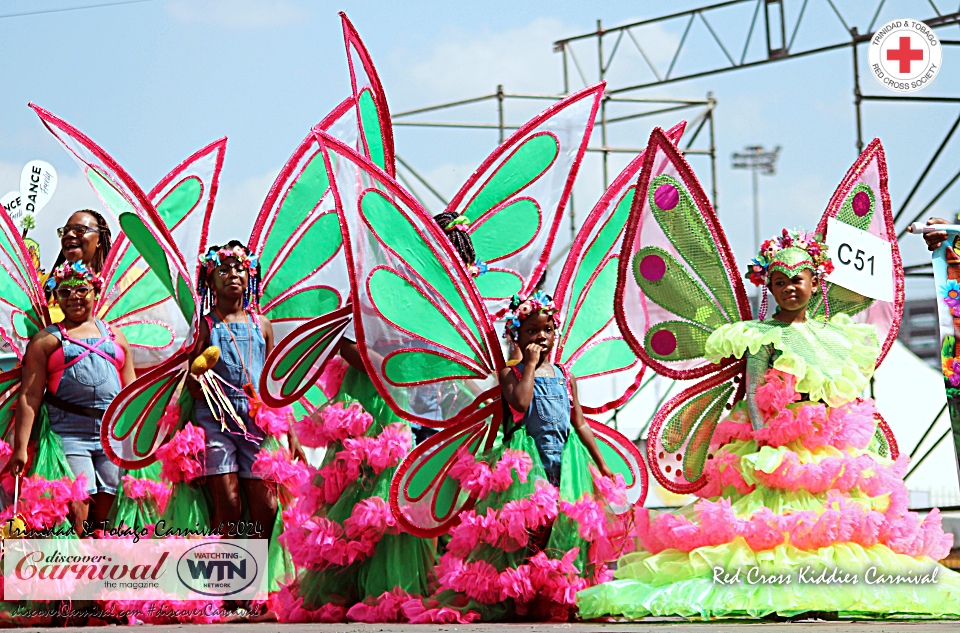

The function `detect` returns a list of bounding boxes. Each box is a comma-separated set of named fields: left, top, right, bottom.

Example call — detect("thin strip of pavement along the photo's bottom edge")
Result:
left=20, top=619, right=960, bottom=633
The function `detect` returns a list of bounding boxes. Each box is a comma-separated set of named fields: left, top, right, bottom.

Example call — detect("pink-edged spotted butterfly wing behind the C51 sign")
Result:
left=807, top=139, right=904, bottom=367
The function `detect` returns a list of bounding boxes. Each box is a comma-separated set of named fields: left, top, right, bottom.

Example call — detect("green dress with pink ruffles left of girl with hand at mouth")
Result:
left=274, top=367, right=436, bottom=622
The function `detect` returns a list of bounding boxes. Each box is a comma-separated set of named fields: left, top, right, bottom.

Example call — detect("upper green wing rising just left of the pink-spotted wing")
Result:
left=553, top=123, right=686, bottom=414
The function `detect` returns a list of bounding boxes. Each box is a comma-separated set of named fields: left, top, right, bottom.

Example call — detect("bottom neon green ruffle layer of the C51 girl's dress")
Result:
left=577, top=537, right=960, bottom=619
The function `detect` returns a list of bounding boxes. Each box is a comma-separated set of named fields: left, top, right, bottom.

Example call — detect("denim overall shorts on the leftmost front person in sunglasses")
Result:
left=45, top=319, right=123, bottom=495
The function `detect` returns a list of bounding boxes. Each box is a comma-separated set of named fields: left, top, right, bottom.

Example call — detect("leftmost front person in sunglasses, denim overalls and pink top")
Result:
left=10, top=260, right=134, bottom=534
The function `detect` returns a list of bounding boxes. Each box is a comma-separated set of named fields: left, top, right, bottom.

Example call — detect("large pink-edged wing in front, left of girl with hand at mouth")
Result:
left=317, top=131, right=503, bottom=427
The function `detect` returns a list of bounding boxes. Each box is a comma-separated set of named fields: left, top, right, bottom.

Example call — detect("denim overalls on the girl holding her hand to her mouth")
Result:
left=513, top=363, right=570, bottom=486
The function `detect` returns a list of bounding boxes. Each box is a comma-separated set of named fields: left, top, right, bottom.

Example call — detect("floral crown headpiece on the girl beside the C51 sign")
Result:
left=746, top=229, right=833, bottom=321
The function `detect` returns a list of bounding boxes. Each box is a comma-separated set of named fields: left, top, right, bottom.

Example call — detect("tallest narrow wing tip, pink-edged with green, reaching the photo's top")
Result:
left=340, top=11, right=397, bottom=177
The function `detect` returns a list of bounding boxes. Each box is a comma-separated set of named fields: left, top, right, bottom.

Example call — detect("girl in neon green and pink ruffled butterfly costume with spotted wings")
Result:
left=577, top=132, right=960, bottom=618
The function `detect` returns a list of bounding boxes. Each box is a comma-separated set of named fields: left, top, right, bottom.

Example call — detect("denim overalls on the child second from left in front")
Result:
left=194, top=314, right=267, bottom=479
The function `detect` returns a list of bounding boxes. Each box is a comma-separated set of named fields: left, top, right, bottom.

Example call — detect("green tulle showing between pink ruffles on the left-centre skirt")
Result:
left=295, top=367, right=436, bottom=611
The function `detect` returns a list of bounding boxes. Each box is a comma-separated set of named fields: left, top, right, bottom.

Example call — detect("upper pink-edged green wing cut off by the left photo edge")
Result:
left=0, top=208, right=50, bottom=359
